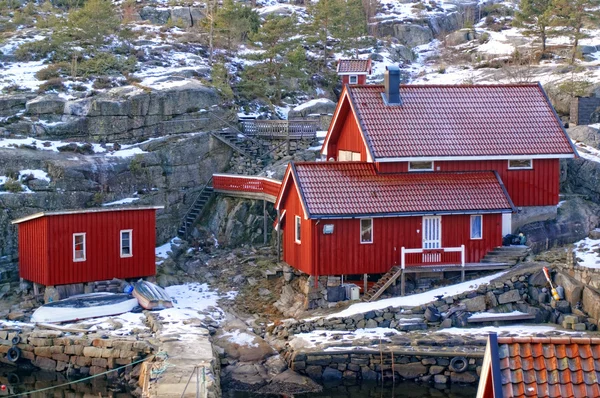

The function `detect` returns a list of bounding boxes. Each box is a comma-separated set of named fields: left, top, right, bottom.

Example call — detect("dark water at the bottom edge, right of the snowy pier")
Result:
left=223, top=382, right=477, bottom=398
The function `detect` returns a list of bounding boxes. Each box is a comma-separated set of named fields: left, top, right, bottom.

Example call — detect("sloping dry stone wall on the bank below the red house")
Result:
left=269, top=263, right=600, bottom=339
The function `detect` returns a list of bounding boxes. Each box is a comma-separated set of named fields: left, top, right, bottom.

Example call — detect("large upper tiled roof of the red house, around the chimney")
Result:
left=348, top=84, right=574, bottom=158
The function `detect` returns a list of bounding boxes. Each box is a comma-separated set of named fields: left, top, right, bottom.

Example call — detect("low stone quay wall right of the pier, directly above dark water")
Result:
left=283, top=346, right=485, bottom=384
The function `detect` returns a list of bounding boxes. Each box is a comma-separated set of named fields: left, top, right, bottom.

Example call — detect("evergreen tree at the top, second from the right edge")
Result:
left=514, top=0, right=553, bottom=54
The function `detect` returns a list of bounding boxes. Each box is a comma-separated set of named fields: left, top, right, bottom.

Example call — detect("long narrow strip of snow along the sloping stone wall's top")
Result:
left=316, top=271, right=508, bottom=318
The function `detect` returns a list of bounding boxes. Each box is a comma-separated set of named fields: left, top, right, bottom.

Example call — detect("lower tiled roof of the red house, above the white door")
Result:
left=292, top=162, right=513, bottom=217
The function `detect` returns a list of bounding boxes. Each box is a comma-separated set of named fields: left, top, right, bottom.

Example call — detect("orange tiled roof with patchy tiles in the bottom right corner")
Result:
left=498, top=337, right=600, bottom=398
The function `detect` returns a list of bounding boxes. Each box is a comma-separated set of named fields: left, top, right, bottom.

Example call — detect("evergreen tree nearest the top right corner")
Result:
left=552, top=0, right=600, bottom=63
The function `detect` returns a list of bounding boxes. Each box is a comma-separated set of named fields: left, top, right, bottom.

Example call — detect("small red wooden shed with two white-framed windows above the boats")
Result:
left=12, top=206, right=162, bottom=286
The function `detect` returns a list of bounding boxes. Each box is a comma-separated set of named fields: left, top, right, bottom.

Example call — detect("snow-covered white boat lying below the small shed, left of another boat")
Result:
left=31, top=293, right=138, bottom=323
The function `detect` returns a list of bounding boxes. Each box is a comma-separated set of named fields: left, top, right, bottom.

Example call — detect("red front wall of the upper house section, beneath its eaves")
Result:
left=377, top=159, right=560, bottom=206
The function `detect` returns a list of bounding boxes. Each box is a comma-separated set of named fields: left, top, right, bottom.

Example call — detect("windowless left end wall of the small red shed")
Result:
left=19, top=217, right=49, bottom=285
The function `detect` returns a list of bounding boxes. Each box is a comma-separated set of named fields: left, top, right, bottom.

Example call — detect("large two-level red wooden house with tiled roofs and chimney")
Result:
left=276, top=68, right=576, bottom=275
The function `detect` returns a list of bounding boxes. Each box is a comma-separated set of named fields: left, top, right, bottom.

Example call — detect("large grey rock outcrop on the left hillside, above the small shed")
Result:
left=0, top=79, right=224, bottom=143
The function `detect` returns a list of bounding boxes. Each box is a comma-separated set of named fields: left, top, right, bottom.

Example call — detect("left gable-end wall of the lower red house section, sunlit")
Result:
left=280, top=184, right=313, bottom=275
